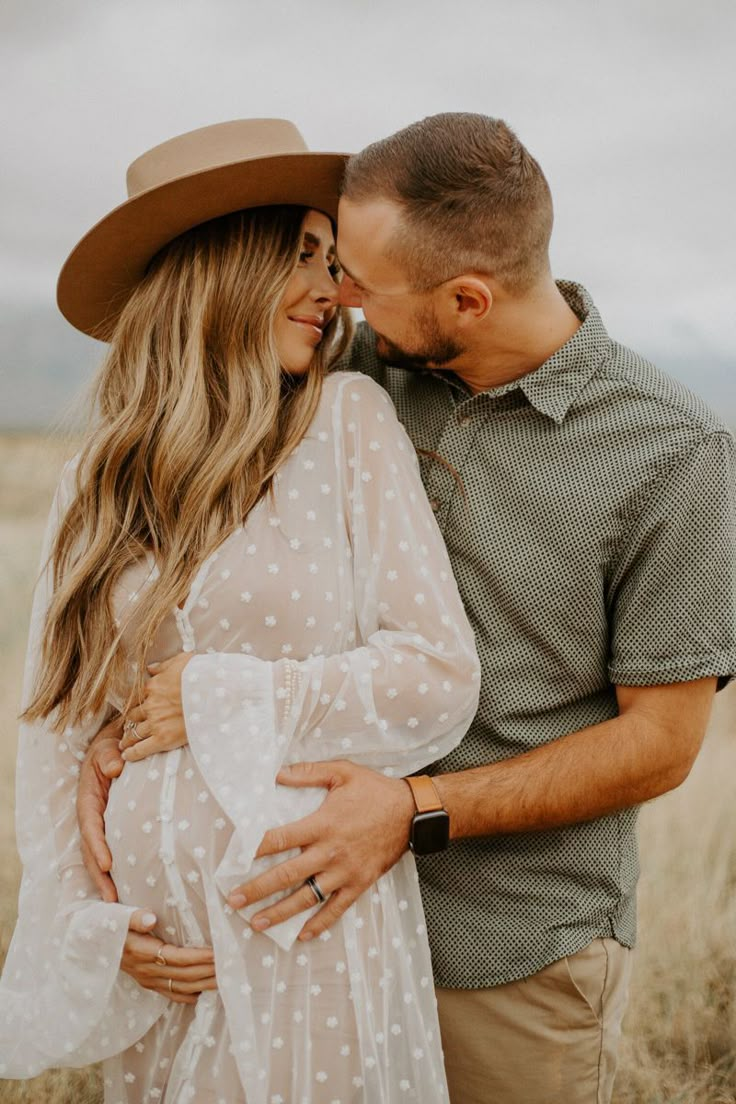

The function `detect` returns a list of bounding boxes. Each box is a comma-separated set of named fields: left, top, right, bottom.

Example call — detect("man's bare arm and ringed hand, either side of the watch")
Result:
left=230, top=679, right=716, bottom=938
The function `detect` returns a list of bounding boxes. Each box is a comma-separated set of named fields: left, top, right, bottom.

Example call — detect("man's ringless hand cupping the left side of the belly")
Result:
left=76, top=716, right=125, bottom=902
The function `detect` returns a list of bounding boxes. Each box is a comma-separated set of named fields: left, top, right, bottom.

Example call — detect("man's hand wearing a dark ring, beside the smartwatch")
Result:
left=228, top=760, right=415, bottom=940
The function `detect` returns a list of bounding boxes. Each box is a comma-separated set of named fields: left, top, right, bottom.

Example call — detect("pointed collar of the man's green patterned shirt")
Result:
left=447, top=280, right=611, bottom=425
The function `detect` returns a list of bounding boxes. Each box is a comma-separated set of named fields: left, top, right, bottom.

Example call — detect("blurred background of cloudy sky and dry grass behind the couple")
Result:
left=0, top=0, right=736, bottom=1104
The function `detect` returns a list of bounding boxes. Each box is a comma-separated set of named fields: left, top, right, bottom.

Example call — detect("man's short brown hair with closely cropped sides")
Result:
left=342, top=112, right=553, bottom=294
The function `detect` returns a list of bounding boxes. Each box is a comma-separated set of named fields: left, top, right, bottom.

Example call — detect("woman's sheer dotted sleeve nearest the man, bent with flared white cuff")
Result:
left=182, top=376, right=480, bottom=945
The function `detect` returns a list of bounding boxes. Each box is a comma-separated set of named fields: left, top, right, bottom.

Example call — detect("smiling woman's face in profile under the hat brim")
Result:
left=274, top=211, right=339, bottom=375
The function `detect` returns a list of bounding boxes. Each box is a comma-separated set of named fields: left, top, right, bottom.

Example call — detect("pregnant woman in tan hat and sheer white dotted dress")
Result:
left=0, top=120, right=478, bottom=1104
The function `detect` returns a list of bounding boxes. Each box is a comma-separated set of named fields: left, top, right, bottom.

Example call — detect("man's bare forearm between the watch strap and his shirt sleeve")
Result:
left=433, top=680, right=713, bottom=838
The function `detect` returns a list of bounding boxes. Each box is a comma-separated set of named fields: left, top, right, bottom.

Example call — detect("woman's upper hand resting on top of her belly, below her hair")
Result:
left=120, top=651, right=192, bottom=763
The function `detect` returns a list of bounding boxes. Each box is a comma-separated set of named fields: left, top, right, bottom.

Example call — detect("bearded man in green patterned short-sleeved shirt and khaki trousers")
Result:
left=81, top=115, right=736, bottom=1104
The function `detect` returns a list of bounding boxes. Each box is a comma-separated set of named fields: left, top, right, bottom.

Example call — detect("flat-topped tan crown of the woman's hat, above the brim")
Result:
left=126, top=119, right=307, bottom=199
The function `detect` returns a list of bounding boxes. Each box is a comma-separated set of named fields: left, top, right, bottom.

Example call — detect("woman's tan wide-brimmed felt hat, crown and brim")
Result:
left=56, top=119, right=349, bottom=341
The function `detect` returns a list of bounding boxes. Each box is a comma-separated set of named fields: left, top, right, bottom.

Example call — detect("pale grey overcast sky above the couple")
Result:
left=0, top=0, right=736, bottom=366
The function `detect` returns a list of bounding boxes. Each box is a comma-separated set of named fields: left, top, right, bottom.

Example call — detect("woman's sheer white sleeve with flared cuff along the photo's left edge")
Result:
left=0, top=467, right=167, bottom=1078
